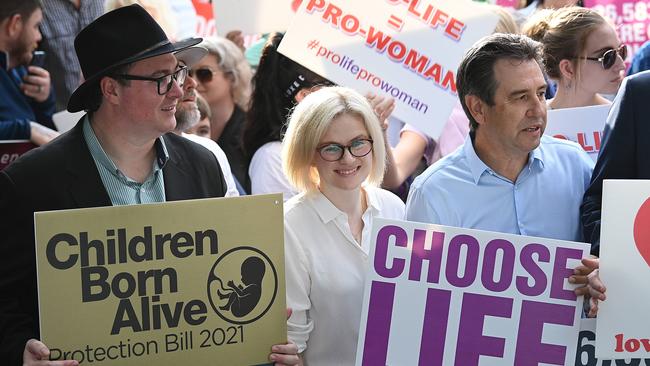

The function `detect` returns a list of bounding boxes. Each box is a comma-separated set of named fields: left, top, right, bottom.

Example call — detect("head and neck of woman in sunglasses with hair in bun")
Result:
left=524, top=7, right=627, bottom=109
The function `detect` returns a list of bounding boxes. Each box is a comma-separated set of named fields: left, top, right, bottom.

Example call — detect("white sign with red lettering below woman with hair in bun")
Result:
left=544, top=105, right=611, bottom=162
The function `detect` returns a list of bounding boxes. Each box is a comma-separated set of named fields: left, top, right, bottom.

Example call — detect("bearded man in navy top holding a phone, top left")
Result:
left=0, top=0, right=58, bottom=145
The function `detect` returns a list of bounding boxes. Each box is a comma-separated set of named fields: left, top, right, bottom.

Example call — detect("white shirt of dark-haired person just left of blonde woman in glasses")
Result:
left=248, top=141, right=298, bottom=201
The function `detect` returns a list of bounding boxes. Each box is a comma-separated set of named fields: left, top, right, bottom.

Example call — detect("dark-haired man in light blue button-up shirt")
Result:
left=406, top=34, right=593, bottom=241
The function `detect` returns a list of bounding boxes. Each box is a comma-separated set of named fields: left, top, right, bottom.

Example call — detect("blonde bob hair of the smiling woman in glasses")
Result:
left=282, top=87, right=386, bottom=192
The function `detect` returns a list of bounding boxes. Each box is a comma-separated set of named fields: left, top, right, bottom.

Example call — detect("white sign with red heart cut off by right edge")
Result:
left=596, top=180, right=650, bottom=359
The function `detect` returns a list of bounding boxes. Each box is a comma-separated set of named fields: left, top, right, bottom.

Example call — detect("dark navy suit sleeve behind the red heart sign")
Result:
left=580, top=77, right=650, bottom=256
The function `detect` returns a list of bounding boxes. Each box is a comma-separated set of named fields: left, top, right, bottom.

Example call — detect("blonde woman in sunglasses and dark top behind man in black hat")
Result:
left=190, top=37, right=252, bottom=193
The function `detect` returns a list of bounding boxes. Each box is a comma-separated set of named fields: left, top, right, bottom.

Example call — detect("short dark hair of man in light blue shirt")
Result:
left=456, top=33, right=544, bottom=131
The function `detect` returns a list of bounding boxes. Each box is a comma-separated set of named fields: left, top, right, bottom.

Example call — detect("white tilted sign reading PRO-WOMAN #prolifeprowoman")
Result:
left=279, top=0, right=497, bottom=138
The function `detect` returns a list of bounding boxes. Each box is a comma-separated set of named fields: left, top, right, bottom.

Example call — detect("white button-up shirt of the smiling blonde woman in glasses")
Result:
left=284, top=187, right=404, bottom=366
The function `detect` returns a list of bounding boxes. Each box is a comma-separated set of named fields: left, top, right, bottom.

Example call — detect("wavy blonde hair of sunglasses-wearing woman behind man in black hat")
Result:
left=200, top=37, right=253, bottom=111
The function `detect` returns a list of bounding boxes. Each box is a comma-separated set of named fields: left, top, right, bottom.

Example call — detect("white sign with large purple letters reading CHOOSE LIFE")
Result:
left=356, top=219, right=589, bottom=366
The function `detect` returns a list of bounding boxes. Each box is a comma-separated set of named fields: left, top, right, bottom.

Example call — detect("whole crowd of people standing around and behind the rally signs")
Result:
left=0, top=0, right=636, bottom=365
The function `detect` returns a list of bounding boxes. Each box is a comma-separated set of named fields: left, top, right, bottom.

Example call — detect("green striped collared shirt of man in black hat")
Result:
left=83, top=115, right=169, bottom=206
